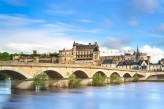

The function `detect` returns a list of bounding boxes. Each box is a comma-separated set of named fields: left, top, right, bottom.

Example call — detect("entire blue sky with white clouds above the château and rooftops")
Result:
left=0, top=0, right=164, bottom=62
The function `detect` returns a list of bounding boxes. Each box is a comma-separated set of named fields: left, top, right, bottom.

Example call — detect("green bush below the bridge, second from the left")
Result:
left=68, top=74, right=80, bottom=88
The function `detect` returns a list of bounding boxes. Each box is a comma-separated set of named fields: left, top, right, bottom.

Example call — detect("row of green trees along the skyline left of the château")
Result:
left=0, top=50, right=59, bottom=61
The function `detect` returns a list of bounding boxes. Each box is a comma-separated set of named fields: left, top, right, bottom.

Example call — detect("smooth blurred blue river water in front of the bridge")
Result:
left=0, top=82, right=164, bottom=109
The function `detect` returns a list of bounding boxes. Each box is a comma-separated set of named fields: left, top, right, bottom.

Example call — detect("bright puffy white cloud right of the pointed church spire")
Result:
left=140, top=45, right=164, bottom=63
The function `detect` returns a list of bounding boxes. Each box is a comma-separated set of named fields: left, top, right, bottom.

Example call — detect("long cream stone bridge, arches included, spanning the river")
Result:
left=0, top=62, right=164, bottom=89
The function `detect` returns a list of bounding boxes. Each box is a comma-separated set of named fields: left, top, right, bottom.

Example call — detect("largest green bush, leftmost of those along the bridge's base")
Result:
left=32, top=73, right=49, bottom=89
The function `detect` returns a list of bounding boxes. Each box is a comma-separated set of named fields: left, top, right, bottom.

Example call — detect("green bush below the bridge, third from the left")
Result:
left=92, top=73, right=106, bottom=86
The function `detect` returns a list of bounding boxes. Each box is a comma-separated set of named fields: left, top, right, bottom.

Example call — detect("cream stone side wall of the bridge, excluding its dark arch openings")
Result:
left=0, top=62, right=164, bottom=78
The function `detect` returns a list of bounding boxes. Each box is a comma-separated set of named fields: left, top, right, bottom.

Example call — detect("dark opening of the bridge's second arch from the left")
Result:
left=44, top=70, right=64, bottom=79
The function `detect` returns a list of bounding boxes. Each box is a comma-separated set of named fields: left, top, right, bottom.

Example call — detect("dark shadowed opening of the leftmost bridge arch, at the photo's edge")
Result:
left=0, top=70, right=27, bottom=80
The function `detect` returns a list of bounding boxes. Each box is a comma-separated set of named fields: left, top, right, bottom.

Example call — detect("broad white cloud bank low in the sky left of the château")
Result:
left=0, top=29, right=86, bottom=53
